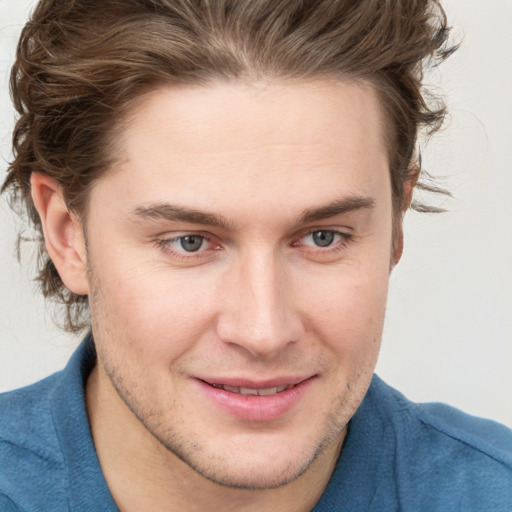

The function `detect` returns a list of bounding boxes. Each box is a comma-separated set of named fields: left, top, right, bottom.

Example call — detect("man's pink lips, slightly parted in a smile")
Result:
left=194, top=376, right=314, bottom=422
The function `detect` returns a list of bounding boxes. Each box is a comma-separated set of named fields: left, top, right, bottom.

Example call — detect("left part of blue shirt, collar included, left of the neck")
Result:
left=0, top=337, right=117, bottom=512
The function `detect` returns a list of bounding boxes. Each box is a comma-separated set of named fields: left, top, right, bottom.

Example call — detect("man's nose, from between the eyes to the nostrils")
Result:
left=217, top=248, right=304, bottom=358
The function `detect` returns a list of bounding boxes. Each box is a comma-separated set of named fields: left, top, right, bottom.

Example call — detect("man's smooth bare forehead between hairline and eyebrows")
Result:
left=98, top=81, right=387, bottom=219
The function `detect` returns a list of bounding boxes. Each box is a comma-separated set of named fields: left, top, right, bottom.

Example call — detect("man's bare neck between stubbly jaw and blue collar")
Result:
left=86, top=366, right=346, bottom=512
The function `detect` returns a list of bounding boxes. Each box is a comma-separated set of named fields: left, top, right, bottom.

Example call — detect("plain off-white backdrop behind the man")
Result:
left=0, top=0, right=512, bottom=427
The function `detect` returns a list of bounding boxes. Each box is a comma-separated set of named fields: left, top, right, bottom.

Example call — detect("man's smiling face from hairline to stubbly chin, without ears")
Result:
left=87, top=82, right=392, bottom=488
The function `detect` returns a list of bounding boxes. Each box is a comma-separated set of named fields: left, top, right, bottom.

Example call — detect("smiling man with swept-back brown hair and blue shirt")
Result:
left=0, top=0, right=512, bottom=511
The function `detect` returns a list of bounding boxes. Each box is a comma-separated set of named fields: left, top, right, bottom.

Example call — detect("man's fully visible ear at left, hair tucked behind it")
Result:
left=30, top=173, right=89, bottom=295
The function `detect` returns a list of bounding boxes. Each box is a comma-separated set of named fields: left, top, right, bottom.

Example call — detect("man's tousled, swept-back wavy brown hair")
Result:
left=2, top=0, right=453, bottom=331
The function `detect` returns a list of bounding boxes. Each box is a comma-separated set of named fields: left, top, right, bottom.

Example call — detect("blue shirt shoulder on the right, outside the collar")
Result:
left=374, top=378, right=512, bottom=510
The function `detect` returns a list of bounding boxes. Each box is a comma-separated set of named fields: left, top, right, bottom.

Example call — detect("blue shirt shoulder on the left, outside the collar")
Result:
left=0, top=374, right=68, bottom=510
